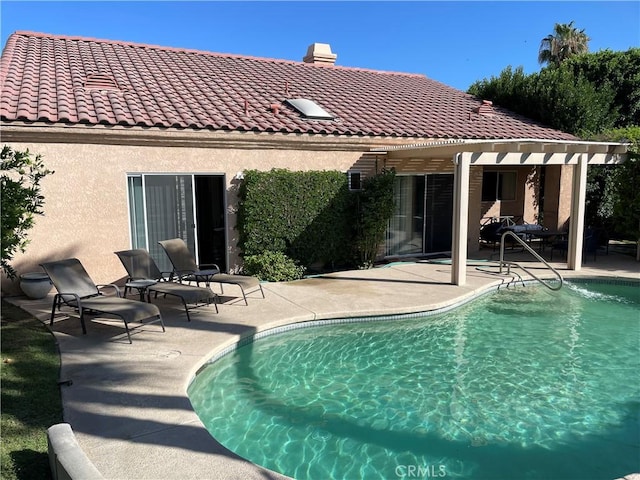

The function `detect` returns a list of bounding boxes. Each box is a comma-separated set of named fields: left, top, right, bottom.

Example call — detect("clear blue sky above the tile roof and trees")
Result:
left=0, top=0, right=640, bottom=90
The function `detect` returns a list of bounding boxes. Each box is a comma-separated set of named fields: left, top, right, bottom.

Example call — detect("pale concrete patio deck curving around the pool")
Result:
left=8, top=253, right=640, bottom=480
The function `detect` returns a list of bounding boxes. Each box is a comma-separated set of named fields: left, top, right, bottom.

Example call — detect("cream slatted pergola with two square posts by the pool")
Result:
left=373, top=139, right=628, bottom=285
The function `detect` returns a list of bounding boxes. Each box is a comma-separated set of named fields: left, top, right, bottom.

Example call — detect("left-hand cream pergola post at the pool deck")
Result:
left=451, top=153, right=471, bottom=285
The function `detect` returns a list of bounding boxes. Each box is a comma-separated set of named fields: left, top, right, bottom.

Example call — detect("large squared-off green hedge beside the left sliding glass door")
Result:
left=238, top=169, right=354, bottom=266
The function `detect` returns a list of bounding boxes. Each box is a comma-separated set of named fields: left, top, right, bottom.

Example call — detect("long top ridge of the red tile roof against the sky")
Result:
left=7, top=30, right=428, bottom=79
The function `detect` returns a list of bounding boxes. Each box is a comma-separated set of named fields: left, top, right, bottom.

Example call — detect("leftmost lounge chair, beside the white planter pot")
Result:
left=41, top=258, right=165, bottom=343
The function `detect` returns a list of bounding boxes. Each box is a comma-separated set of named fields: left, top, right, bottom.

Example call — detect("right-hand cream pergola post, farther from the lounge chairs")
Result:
left=567, top=153, right=589, bottom=270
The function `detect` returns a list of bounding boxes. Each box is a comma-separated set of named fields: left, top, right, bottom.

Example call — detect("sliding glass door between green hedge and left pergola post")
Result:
left=386, top=174, right=453, bottom=256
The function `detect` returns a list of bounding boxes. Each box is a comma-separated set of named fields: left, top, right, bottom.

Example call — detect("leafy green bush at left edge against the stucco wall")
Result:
left=0, top=145, right=53, bottom=278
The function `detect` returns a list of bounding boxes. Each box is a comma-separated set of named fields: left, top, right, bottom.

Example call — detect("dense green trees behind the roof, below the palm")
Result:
left=468, top=48, right=640, bottom=137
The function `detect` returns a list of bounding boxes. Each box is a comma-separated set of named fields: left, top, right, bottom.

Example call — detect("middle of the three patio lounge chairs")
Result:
left=114, top=248, right=218, bottom=321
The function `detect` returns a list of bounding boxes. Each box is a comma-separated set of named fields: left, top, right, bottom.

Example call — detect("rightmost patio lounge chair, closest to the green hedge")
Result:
left=158, top=238, right=265, bottom=305
